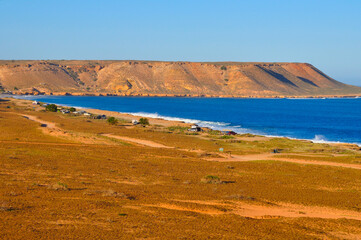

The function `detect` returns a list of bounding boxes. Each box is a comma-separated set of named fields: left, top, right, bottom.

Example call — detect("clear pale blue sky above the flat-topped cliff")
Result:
left=0, top=0, right=361, bottom=86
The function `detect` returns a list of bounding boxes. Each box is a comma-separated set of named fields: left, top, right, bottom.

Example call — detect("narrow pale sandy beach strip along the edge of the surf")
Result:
left=7, top=95, right=361, bottom=147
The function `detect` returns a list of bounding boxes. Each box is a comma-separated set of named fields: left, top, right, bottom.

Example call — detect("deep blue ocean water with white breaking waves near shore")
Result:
left=14, top=96, right=361, bottom=144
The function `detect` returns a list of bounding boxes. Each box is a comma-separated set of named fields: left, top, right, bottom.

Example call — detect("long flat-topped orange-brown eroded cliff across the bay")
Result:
left=0, top=61, right=361, bottom=97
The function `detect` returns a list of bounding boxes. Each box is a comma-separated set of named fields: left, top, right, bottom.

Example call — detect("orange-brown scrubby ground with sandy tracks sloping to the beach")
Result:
left=0, top=99, right=361, bottom=239
